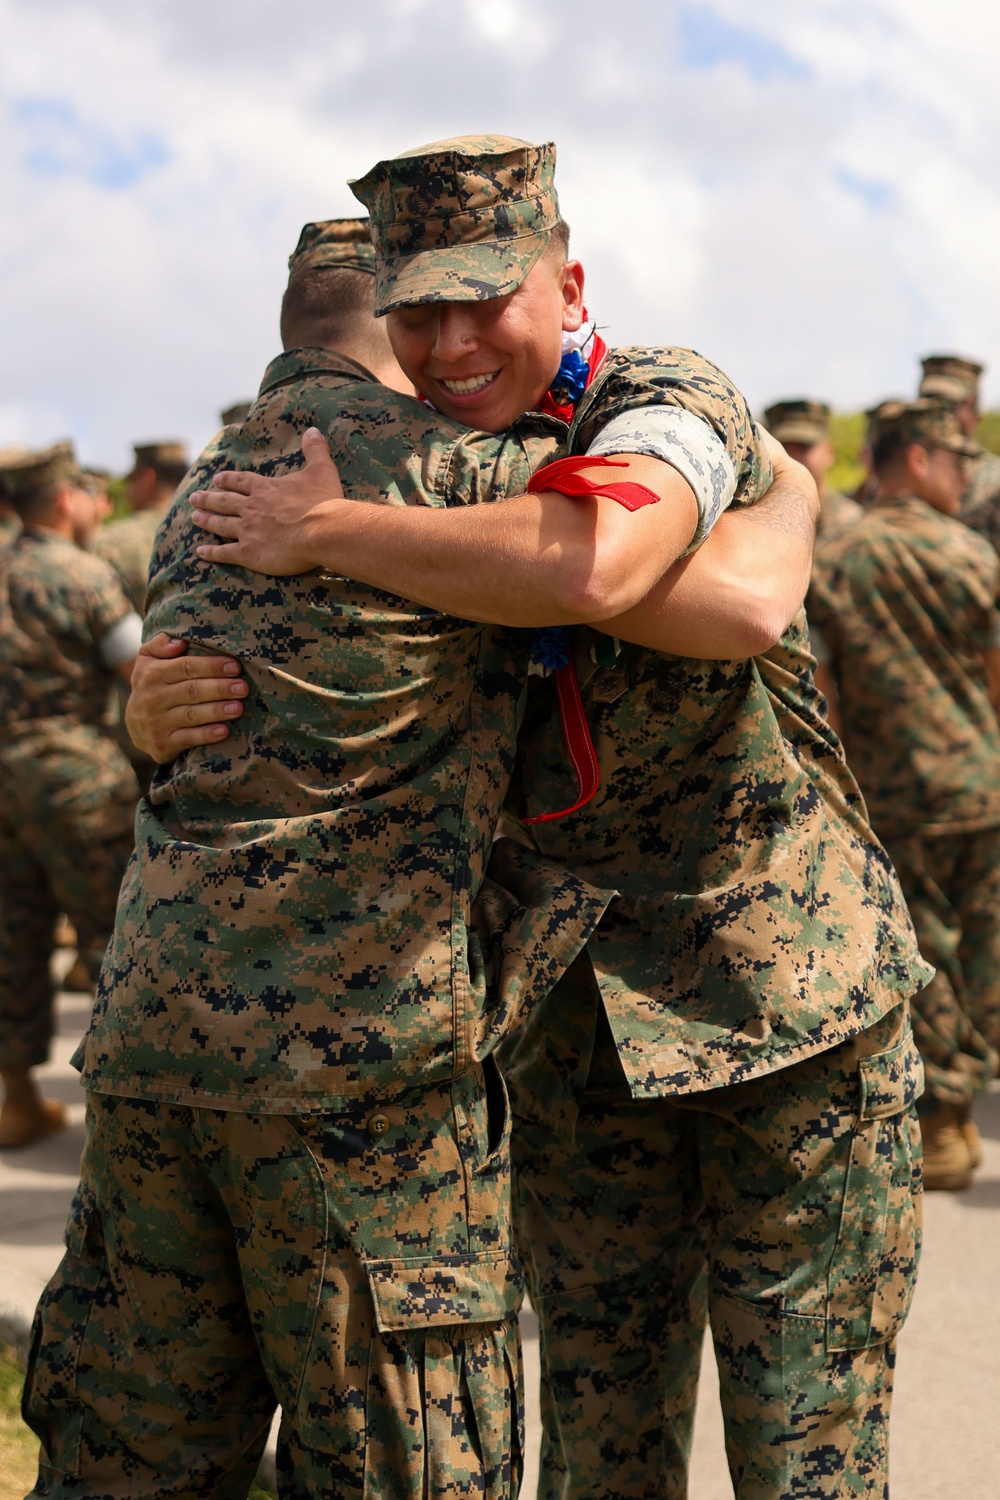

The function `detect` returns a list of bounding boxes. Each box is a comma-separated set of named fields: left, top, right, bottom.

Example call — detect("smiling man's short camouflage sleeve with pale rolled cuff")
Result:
left=570, top=348, right=774, bottom=516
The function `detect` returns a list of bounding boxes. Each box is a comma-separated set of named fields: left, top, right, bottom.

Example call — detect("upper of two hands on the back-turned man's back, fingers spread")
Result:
left=190, top=428, right=347, bottom=576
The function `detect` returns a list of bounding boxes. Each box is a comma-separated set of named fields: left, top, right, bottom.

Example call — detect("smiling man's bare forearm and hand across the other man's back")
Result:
left=192, top=429, right=699, bottom=626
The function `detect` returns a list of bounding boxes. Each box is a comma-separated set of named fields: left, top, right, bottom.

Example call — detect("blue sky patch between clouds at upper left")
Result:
left=13, top=99, right=169, bottom=189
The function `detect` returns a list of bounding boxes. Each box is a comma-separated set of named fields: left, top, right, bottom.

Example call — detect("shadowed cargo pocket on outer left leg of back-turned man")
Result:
left=21, top=1182, right=106, bottom=1475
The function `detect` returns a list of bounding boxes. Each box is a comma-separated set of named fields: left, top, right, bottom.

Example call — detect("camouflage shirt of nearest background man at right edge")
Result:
left=810, top=495, right=1000, bottom=836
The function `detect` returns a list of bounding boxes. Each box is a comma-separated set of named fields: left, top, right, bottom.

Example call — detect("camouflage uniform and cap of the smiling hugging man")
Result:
left=177, top=140, right=930, bottom=1497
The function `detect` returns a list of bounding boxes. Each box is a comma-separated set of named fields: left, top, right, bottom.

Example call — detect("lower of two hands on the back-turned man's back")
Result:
left=124, top=635, right=249, bottom=765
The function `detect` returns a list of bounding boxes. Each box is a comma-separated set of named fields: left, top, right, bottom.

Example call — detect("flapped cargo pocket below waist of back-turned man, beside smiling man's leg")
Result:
left=364, top=1256, right=523, bottom=1500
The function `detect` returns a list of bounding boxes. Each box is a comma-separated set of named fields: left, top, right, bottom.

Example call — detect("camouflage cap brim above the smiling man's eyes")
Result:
left=375, top=230, right=552, bottom=318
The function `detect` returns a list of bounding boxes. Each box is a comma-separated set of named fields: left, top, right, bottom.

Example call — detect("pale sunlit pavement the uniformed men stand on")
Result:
left=0, top=996, right=1000, bottom=1500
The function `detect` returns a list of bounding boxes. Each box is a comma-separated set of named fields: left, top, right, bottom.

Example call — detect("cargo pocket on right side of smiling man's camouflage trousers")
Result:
left=826, top=1032, right=924, bottom=1352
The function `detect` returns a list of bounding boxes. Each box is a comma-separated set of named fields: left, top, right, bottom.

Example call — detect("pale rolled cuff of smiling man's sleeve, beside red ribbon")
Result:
left=586, top=407, right=736, bottom=552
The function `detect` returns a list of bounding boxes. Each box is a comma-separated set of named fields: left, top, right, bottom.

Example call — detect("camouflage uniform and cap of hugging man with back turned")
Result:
left=25, top=221, right=606, bottom=1500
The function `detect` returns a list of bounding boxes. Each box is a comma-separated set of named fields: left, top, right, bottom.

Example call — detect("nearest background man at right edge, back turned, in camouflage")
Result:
left=810, top=401, right=1000, bottom=1187
